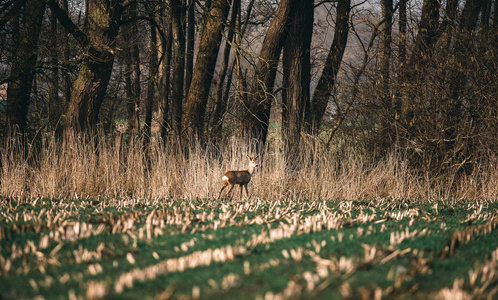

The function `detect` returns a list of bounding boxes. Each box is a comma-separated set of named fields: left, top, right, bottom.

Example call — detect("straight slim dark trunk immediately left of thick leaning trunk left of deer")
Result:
left=170, top=0, right=185, bottom=140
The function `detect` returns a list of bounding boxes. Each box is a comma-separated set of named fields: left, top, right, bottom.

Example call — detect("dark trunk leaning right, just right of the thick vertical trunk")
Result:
left=311, top=0, right=351, bottom=134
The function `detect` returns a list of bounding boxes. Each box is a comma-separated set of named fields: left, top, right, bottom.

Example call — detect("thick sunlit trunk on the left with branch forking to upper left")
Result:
left=47, top=0, right=124, bottom=135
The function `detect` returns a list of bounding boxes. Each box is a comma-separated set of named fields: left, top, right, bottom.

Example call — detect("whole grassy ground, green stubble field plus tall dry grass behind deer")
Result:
left=0, top=139, right=498, bottom=299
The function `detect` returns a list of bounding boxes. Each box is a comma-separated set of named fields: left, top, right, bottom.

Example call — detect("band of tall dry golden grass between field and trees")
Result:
left=0, top=137, right=498, bottom=200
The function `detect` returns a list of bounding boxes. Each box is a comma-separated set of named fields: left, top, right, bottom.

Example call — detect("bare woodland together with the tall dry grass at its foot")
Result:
left=0, top=0, right=498, bottom=199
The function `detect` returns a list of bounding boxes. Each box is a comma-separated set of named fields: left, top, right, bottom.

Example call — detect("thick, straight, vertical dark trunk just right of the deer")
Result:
left=282, top=0, right=313, bottom=165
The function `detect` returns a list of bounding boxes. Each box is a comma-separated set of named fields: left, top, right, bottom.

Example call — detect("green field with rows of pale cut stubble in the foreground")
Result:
left=0, top=196, right=498, bottom=299
